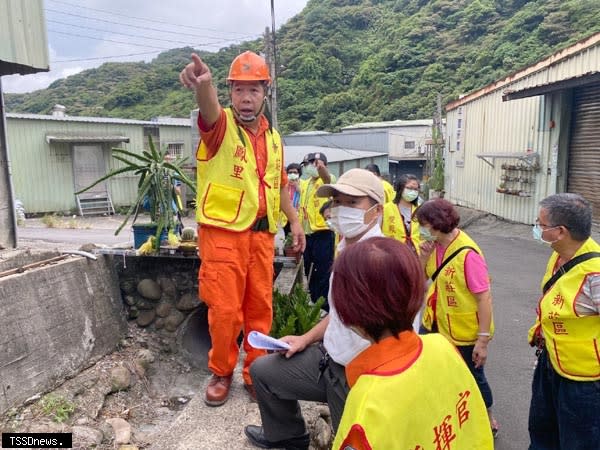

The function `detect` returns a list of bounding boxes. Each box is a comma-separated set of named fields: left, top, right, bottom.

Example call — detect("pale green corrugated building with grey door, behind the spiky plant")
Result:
left=7, top=105, right=192, bottom=213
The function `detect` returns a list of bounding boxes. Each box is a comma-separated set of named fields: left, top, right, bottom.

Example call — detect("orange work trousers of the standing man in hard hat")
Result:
left=198, top=226, right=275, bottom=384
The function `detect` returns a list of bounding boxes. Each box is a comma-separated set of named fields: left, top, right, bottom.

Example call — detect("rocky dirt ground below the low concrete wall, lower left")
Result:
left=0, top=322, right=206, bottom=450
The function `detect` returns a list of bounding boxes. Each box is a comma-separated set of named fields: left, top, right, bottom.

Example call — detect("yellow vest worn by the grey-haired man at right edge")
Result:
left=529, top=238, right=600, bottom=381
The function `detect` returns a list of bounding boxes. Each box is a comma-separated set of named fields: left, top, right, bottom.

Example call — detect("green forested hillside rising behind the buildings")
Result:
left=5, top=0, right=600, bottom=132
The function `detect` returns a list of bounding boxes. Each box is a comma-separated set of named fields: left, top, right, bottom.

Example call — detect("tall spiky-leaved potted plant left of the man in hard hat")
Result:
left=75, top=136, right=196, bottom=250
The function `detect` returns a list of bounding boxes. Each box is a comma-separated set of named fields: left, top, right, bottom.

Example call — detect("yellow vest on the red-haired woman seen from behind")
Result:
left=333, top=334, right=494, bottom=450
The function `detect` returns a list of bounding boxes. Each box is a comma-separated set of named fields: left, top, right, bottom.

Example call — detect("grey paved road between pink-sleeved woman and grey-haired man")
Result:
left=467, top=227, right=550, bottom=450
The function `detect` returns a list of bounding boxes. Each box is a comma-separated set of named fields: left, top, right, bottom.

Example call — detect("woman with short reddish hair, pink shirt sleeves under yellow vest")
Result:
left=416, top=198, right=498, bottom=437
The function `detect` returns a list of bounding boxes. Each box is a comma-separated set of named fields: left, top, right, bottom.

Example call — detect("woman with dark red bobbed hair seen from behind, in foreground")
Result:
left=331, top=237, right=493, bottom=450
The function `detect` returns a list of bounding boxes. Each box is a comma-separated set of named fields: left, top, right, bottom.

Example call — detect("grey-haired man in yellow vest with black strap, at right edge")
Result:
left=529, top=193, right=600, bottom=449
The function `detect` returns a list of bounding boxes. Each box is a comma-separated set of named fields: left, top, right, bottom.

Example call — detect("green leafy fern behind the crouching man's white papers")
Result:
left=271, top=285, right=325, bottom=338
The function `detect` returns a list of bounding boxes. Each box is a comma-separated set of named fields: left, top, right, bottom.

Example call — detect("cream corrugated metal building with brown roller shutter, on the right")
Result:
left=445, top=33, right=600, bottom=223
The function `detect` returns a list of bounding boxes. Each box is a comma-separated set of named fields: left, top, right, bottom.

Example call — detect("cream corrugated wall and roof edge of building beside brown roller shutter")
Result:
left=445, top=37, right=600, bottom=223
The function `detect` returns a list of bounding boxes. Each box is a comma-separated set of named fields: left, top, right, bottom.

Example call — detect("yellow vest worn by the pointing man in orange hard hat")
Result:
left=196, top=108, right=283, bottom=233
